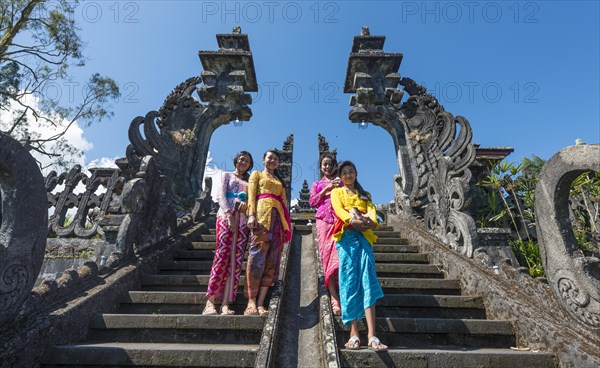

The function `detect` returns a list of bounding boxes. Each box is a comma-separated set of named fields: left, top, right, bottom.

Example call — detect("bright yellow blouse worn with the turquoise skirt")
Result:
left=331, top=187, right=379, bottom=245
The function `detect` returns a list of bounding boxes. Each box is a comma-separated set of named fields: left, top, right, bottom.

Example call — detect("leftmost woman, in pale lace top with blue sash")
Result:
left=202, top=151, right=254, bottom=315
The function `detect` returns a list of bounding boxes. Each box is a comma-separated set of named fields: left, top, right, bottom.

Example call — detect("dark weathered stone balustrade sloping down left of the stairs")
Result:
left=0, top=224, right=207, bottom=368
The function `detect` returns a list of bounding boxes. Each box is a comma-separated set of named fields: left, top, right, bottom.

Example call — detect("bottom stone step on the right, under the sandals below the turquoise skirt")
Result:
left=340, top=348, right=556, bottom=368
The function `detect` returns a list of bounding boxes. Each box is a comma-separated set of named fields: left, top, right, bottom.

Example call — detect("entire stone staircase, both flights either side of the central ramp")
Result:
left=42, top=221, right=556, bottom=368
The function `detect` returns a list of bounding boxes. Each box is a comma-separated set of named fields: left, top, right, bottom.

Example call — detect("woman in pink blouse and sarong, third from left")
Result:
left=309, top=153, right=341, bottom=316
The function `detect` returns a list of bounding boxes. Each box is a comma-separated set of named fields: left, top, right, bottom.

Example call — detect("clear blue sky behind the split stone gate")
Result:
left=57, top=1, right=600, bottom=203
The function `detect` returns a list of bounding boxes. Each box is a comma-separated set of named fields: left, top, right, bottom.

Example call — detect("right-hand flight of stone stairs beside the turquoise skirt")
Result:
left=335, top=227, right=556, bottom=368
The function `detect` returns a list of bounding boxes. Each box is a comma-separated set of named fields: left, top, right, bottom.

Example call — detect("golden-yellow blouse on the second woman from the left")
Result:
left=248, top=171, right=291, bottom=231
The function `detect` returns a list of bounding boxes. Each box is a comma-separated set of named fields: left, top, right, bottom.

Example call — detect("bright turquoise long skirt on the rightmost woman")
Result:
left=336, top=230, right=383, bottom=325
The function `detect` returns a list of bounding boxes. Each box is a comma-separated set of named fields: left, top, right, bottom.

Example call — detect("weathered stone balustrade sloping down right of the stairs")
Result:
left=390, top=215, right=600, bottom=368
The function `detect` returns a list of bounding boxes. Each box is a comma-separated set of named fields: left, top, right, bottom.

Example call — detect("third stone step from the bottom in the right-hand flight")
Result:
left=377, top=294, right=486, bottom=319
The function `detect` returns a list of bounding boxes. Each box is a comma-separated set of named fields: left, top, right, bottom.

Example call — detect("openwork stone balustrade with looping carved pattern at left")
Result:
left=45, top=165, right=125, bottom=239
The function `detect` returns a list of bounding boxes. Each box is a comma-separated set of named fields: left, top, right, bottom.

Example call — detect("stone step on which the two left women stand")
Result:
left=88, top=314, right=266, bottom=344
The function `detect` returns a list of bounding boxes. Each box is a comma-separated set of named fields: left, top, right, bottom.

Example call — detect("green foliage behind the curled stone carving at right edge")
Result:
left=477, top=155, right=600, bottom=277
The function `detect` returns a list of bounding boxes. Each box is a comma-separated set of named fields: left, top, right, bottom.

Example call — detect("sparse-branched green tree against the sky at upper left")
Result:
left=0, top=0, right=120, bottom=167
